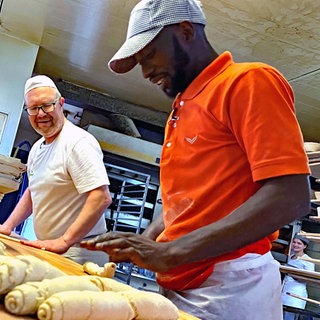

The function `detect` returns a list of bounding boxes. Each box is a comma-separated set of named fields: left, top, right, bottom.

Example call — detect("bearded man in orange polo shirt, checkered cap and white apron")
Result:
left=80, top=0, right=310, bottom=320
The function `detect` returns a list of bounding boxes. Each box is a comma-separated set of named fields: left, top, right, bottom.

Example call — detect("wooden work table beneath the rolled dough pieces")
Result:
left=0, top=238, right=200, bottom=320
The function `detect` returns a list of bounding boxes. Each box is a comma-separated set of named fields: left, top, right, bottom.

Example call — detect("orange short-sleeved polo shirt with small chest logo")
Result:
left=157, top=52, right=309, bottom=290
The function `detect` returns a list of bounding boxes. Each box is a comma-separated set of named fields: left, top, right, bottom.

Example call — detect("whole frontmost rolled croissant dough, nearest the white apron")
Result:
left=37, top=289, right=179, bottom=320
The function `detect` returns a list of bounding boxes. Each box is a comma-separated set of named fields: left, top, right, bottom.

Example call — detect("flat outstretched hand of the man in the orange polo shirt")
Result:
left=80, top=232, right=177, bottom=272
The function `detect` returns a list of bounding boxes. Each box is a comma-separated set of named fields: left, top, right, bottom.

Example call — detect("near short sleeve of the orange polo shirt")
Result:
left=228, top=67, right=309, bottom=181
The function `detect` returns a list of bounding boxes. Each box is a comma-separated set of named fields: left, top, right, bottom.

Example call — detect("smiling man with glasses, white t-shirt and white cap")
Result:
left=0, top=75, right=112, bottom=265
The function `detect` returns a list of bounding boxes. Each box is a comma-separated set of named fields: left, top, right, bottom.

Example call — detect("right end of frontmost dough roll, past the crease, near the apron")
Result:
left=119, top=290, right=179, bottom=320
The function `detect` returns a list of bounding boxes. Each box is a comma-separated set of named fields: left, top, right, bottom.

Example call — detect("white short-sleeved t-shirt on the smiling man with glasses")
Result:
left=27, top=121, right=109, bottom=240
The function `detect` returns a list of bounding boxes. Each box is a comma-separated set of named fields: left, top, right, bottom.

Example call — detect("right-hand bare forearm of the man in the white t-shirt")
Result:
left=63, top=186, right=112, bottom=246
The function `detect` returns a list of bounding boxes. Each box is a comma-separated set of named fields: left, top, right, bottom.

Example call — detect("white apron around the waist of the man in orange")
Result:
left=164, top=252, right=282, bottom=320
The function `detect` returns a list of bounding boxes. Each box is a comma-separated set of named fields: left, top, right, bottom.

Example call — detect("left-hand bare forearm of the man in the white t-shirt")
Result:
left=3, top=188, right=32, bottom=231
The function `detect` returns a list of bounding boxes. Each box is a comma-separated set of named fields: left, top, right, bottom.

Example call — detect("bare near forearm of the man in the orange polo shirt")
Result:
left=169, top=175, right=310, bottom=264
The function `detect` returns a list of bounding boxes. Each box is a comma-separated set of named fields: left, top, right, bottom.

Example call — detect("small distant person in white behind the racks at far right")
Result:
left=282, top=234, right=315, bottom=320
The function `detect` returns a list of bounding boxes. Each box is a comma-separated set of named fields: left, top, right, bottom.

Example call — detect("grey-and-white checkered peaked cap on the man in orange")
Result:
left=108, top=0, right=206, bottom=73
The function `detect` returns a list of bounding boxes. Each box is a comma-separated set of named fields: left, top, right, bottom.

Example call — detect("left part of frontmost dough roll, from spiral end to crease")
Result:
left=37, top=291, right=135, bottom=320
